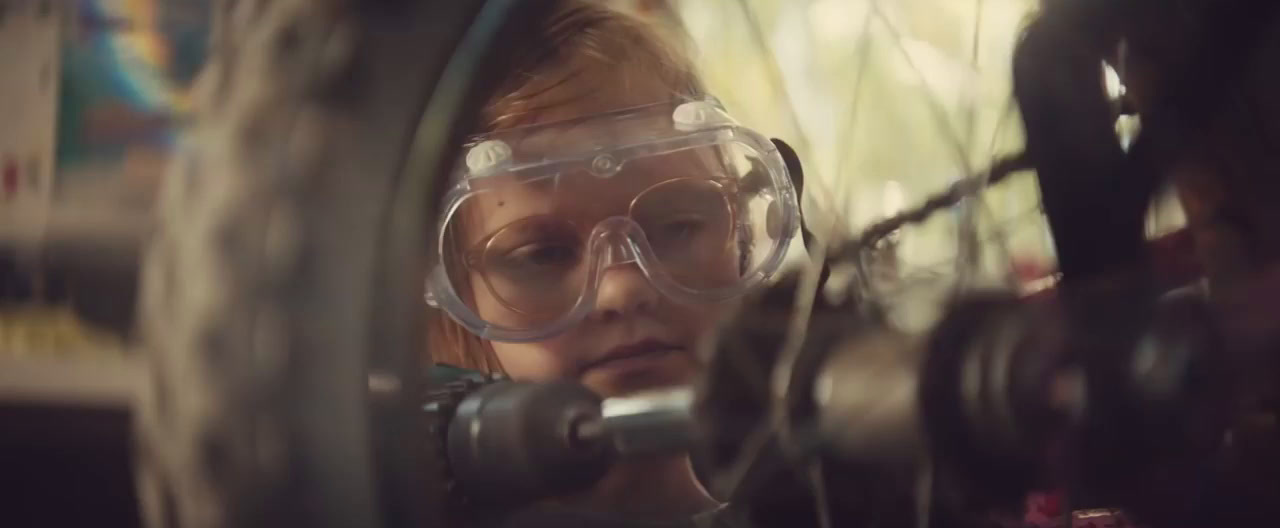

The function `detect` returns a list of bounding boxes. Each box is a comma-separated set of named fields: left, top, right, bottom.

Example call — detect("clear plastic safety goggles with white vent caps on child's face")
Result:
left=426, top=99, right=800, bottom=342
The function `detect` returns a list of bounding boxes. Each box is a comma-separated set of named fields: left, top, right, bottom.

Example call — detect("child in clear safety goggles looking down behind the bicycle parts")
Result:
left=426, top=0, right=800, bottom=519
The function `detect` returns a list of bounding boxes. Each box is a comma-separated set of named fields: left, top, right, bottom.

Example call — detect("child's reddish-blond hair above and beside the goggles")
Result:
left=428, top=0, right=704, bottom=372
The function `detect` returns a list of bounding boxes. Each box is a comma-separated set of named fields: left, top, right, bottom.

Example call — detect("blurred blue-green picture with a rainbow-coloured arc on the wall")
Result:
left=58, top=0, right=210, bottom=196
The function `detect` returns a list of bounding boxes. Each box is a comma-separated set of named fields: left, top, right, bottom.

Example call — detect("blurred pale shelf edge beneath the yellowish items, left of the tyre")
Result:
left=0, top=358, right=145, bottom=409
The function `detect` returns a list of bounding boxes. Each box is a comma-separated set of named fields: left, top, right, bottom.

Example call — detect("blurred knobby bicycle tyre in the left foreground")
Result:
left=136, top=0, right=558, bottom=527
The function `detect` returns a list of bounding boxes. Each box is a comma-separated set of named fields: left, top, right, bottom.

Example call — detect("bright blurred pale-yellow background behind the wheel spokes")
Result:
left=626, top=0, right=1053, bottom=288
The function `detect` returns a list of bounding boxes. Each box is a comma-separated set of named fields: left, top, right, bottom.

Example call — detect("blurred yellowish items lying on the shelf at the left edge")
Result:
left=0, top=305, right=125, bottom=359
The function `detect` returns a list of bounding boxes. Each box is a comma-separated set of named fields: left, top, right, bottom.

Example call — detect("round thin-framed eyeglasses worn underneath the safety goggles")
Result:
left=448, top=178, right=745, bottom=327
